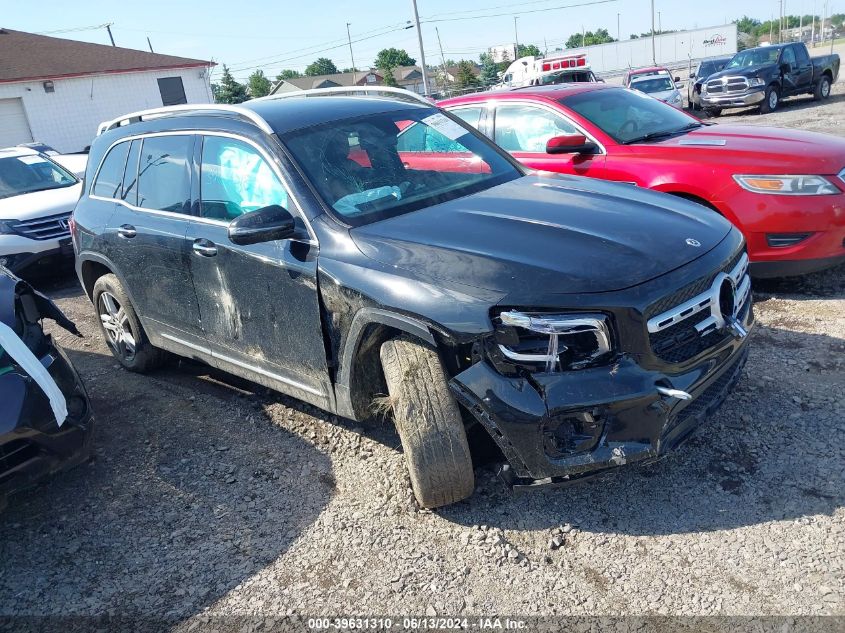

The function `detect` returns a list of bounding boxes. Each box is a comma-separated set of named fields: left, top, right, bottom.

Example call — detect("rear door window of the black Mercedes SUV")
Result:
left=138, top=136, right=193, bottom=213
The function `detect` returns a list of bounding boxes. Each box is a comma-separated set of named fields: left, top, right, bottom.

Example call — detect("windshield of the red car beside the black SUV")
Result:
left=560, top=88, right=701, bottom=143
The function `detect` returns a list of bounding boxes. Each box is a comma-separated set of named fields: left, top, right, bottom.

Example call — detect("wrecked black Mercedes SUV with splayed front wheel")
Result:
left=72, top=89, right=753, bottom=507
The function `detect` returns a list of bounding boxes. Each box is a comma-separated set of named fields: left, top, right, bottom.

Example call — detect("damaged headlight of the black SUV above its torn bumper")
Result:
left=493, top=310, right=612, bottom=373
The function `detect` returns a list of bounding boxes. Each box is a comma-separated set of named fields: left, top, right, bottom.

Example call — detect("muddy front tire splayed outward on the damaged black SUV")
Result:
left=381, top=339, right=475, bottom=508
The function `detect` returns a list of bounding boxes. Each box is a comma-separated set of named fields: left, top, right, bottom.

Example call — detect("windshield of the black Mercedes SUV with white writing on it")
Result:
left=282, top=108, right=522, bottom=226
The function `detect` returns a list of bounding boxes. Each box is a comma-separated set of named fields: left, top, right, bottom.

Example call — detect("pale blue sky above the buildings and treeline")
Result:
left=0, top=0, right=812, bottom=79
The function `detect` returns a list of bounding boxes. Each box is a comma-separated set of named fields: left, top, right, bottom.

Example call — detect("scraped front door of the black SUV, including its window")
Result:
left=187, top=134, right=330, bottom=404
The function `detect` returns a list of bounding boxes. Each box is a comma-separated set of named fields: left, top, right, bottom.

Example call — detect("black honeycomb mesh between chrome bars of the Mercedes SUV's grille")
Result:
left=646, top=250, right=751, bottom=363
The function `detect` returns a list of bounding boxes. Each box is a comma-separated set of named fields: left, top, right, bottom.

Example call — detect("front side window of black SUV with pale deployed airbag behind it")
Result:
left=200, top=136, right=288, bottom=220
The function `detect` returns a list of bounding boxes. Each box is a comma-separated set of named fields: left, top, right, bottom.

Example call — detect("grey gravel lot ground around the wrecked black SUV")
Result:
left=0, top=90, right=845, bottom=629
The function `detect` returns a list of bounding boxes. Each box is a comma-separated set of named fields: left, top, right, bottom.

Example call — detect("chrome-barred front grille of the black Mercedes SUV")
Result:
left=646, top=251, right=751, bottom=363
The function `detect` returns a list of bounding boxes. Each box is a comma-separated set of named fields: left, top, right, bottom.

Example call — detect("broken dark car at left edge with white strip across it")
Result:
left=0, top=268, right=94, bottom=502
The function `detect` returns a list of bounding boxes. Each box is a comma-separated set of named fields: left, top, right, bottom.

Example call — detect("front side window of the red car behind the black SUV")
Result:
left=494, top=104, right=579, bottom=153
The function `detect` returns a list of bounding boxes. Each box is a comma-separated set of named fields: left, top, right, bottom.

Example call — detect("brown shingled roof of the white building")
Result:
left=0, top=28, right=214, bottom=83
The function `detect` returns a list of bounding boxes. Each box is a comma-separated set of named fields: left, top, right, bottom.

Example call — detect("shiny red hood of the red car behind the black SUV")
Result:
left=656, top=123, right=845, bottom=175
